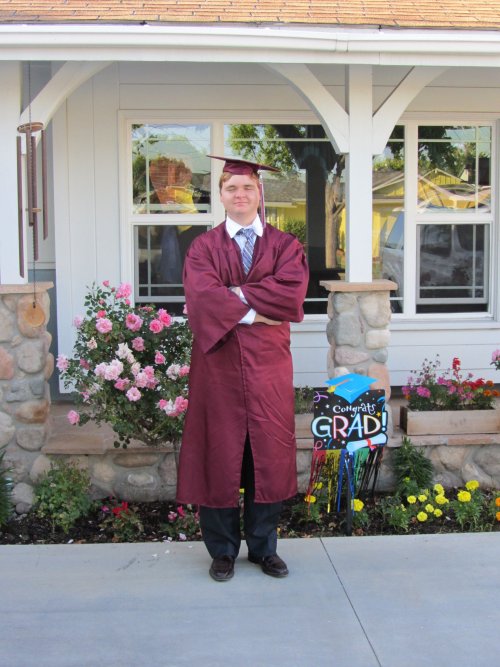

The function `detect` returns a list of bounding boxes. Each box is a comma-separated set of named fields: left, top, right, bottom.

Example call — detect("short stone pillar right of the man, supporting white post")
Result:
left=320, top=280, right=397, bottom=401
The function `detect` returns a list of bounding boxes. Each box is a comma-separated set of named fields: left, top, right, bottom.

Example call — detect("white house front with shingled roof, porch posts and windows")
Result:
left=0, top=0, right=500, bottom=386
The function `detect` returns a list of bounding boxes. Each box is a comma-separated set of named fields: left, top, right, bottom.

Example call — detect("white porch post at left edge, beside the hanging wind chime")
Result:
left=0, top=62, right=24, bottom=285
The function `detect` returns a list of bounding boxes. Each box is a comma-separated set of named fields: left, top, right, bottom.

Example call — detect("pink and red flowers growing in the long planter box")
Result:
left=402, top=356, right=500, bottom=411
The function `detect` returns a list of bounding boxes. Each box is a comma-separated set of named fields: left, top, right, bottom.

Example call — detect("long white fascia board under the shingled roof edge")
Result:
left=0, top=24, right=500, bottom=66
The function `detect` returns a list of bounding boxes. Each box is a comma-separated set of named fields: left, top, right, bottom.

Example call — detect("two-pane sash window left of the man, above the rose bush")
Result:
left=129, top=123, right=213, bottom=314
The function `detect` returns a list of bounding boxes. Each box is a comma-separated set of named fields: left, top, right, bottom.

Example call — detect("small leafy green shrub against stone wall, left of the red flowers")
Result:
left=34, top=460, right=94, bottom=533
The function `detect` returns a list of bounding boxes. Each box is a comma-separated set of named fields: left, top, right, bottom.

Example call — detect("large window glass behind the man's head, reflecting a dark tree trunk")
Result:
left=225, top=125, right=345, bottom=313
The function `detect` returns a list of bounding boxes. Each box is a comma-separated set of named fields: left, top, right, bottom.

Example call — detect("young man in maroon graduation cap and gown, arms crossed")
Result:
left=177, top=158, right=308, bottom=581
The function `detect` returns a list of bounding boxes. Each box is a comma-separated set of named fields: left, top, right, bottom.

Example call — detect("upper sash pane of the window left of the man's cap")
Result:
left=132, top=124, right=210, bottom=214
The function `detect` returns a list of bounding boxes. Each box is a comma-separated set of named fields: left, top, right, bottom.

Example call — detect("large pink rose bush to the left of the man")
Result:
left=57, top=281, right=191, bottom=447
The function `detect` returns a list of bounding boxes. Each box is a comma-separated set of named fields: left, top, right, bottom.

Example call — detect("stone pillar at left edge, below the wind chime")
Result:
left=0, top=283, right=54, bottom=513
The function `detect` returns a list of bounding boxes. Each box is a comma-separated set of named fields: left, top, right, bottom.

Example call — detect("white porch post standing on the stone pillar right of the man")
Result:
left=346, top=65, right=373, bottom=282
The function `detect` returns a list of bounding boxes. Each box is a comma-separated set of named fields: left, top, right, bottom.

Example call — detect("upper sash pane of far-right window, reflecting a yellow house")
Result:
left=418, top=125, right=491, bottom=212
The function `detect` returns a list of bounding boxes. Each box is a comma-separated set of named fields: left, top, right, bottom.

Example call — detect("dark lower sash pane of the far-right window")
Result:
left=417, top=224, right=488, bottom=313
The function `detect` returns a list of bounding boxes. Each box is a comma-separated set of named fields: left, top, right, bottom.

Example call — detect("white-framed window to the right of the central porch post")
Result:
left=373, top=125, right=493, bottom=315
